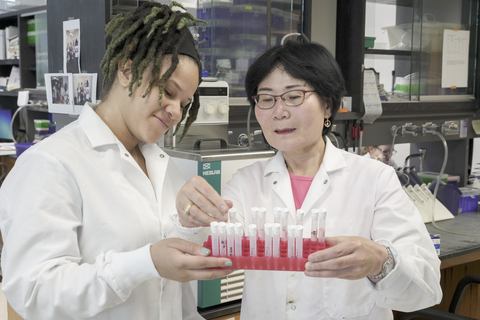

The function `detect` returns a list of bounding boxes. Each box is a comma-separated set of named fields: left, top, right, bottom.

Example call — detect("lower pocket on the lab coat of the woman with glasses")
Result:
left=323, top=279, right=375, bottom=319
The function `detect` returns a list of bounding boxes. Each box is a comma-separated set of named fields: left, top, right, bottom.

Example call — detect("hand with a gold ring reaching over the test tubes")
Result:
left=176, top=176, right=233, bottom=227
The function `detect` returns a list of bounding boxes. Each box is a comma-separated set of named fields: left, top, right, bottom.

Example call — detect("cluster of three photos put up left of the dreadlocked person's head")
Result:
left=45, top=19, right=97, bottom=115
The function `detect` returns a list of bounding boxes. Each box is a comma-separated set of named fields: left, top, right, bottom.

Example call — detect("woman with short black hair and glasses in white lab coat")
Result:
left=175, top=42, right=442, bottom=320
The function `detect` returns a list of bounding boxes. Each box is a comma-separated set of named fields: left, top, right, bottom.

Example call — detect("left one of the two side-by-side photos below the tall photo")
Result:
left=45, top=73, right=73, bottom=114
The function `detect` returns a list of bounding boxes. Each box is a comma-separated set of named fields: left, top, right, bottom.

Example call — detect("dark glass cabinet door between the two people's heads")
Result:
left=194, top=0, right=305, bottom=97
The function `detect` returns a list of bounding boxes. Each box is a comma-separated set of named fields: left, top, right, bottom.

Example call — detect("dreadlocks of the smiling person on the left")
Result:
left=100, top=1, right=206, bottom=141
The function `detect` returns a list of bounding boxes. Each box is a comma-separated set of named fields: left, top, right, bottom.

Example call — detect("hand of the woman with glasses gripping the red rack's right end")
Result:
left=305, top=237, right=388, bottom=280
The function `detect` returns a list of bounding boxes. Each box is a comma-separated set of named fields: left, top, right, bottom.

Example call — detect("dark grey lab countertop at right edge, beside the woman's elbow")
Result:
left=426, top=212, right=480, bottom=267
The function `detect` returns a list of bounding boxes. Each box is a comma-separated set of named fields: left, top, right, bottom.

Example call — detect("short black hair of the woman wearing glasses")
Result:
left=245, top=41, right=346, bottom=136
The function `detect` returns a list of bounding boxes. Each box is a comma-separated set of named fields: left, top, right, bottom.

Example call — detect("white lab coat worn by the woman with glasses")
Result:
left=222, top=139, right=442, bottom=320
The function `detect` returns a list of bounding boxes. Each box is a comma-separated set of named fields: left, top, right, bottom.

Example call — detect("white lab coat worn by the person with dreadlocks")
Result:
left=0, top=105, right=203, bottom=320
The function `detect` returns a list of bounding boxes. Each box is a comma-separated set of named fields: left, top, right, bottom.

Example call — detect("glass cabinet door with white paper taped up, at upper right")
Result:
left=364, top=0, right=478, bottom=102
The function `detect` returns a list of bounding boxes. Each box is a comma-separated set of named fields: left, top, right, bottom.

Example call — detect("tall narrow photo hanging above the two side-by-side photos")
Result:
left=63, top=19, right=81, bottom=73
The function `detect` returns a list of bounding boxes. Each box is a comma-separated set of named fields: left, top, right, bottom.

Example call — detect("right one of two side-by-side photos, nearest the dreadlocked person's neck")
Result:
left=72, top=73, right=97, bottom=114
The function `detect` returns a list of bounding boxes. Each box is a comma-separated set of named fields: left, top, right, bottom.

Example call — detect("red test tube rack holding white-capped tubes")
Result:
left=203, top=236, right=325, bottom=272
